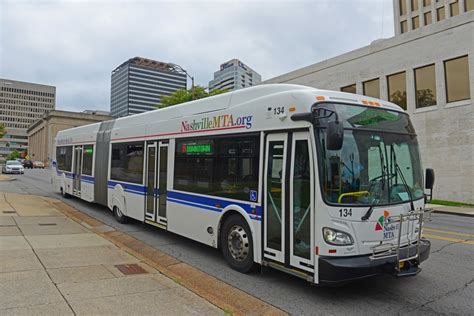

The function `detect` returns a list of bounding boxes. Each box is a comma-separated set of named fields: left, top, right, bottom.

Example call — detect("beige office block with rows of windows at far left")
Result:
left=0, top=79, right=56, bottom=161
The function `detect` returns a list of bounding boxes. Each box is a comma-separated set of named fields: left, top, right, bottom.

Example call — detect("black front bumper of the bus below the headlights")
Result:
left=318, top=239, right=431, bottom=286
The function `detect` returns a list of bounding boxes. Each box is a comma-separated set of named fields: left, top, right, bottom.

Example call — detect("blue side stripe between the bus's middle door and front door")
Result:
left=168, top=191, right=261, bottom=219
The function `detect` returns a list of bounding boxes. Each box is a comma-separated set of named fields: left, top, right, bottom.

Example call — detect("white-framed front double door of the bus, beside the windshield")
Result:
left=263, top=132, right=314, bottom=273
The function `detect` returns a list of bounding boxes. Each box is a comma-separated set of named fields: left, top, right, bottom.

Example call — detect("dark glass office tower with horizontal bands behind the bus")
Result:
left=110, top=57, right=187, bottom=117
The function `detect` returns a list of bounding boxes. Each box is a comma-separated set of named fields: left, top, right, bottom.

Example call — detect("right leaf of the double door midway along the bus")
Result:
left=157, top=141, right=168, bottom=226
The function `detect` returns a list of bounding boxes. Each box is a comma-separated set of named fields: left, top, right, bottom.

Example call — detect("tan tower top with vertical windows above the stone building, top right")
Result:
left=393, top=0, right=474, bottom=35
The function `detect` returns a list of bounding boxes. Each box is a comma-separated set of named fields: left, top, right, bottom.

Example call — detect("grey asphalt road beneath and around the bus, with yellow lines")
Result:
left=0, top=170, right=474, bottom=315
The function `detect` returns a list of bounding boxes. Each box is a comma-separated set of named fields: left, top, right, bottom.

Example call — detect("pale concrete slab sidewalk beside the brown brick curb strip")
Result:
left=0, top=192, right=224, bottom=315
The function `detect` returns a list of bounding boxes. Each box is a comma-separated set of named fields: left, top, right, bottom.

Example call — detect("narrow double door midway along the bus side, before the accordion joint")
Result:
left=145, top=141, right=168, bottom=226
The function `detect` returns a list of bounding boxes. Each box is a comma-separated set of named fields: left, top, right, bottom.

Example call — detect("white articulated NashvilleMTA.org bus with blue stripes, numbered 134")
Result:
left=52, top=85, right=434, bottom=285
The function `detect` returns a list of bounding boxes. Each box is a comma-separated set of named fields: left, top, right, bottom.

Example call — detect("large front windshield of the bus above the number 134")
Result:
left=316, top=104, right=424, bottom=205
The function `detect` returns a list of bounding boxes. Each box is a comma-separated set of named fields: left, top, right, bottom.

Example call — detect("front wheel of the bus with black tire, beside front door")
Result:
left=220, top=214, right=255, bottom=273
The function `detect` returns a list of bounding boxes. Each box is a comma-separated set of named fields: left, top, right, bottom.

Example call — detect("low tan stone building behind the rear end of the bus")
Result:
left=28, top=111, right=112, bottom=166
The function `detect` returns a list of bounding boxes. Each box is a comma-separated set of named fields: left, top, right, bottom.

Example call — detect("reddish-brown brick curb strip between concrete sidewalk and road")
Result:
left=48, top=199, right=288, bottom=315
